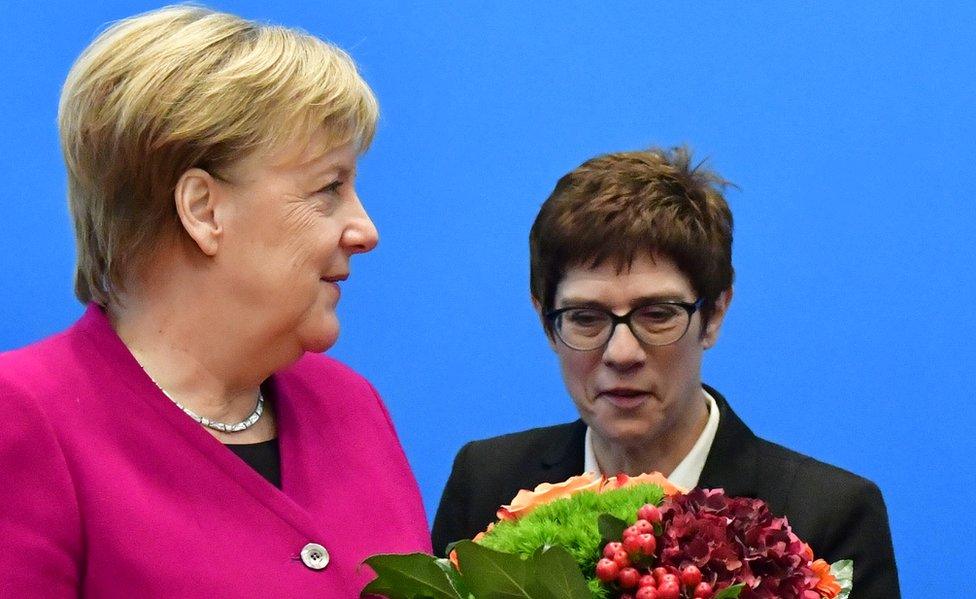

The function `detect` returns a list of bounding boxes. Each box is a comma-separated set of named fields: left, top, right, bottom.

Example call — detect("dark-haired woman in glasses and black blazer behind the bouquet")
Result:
left=433, top=148, right=898, bottom=599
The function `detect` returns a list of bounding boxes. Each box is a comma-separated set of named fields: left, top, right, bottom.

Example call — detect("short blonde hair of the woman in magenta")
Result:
left=58, top=6, right=379, bottom=305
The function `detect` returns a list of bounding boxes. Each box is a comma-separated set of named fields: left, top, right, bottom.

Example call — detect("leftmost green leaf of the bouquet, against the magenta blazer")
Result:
left=362, top=553, right=463, bottom=599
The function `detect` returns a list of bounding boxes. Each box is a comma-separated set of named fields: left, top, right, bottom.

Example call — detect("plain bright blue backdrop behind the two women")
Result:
left=0, top=1, right=976, bottom=597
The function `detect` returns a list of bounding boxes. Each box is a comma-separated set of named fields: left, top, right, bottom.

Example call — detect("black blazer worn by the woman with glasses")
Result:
left=433, top=387, right=900, bottom=599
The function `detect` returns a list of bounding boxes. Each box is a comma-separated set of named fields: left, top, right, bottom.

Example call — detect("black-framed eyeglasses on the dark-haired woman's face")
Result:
left=546, top=298, right=704, bottom=351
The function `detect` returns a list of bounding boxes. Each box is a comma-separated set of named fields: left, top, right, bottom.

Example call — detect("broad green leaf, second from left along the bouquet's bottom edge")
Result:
left=454, top=541, right=532, bottom=599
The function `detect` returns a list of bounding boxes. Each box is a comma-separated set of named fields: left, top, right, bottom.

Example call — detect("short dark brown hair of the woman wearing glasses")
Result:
left=529, top=147, right=733, bottom=334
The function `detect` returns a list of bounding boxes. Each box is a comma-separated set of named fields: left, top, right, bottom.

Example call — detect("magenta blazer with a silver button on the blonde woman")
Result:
left=0, top=306, right=430, bottom=599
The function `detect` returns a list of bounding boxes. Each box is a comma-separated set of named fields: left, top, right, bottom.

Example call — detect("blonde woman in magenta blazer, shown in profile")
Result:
left=0, top=7, right=429, bottom=597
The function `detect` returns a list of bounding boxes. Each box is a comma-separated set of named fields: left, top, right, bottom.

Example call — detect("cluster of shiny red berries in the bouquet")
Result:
left=596, top=503, right=713, bottom=599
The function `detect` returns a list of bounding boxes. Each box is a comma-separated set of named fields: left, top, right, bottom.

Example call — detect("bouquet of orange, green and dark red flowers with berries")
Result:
left=363, top=473, right=853, bottom=599
